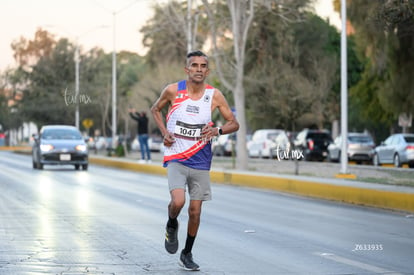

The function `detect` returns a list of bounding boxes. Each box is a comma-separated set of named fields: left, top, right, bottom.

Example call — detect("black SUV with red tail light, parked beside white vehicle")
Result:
left=293, top=129, right=332, bottom=161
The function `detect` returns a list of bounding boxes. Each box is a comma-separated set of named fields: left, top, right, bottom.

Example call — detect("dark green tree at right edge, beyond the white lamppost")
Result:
left=335, top=0, right=414, bottom=134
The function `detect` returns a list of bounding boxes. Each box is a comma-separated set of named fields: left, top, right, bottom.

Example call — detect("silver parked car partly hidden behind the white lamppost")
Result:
left=328, top=133, right=375, bottom=163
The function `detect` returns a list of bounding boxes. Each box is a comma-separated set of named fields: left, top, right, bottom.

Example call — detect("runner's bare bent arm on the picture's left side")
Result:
left=151, top=84, right=177, bottom=147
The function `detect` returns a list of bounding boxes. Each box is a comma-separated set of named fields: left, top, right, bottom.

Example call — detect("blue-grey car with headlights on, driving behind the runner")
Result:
left=32, top=125, right=88, bottom=170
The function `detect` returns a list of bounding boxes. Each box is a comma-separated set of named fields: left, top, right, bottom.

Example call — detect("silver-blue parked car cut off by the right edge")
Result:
left=373, top=134, right=414, bottom=168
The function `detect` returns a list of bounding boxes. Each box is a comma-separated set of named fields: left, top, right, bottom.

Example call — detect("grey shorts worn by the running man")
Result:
left=168, top=162, right=211, bottom=201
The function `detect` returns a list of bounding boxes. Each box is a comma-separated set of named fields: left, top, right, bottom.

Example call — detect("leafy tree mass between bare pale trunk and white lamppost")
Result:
left=246, top=8, right=346, bottom=131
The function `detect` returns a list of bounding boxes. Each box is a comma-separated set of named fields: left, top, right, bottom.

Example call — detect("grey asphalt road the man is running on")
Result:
left=0, top=152, right=414, bottom=275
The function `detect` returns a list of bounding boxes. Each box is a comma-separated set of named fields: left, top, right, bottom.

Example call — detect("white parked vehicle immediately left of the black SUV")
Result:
left=247, top=129, right=289, bottom=158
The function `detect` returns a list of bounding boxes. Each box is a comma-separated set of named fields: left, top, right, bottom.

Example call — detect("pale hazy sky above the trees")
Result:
left=0, top=0, right=340, bottom=72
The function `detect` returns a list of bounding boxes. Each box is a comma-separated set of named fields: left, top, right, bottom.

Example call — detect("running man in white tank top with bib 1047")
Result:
left=151, top=51, right=239, bottom=270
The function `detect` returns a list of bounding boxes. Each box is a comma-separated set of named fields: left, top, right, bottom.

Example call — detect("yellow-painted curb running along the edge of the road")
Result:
left=89, top=157, right=414, bottom=212
